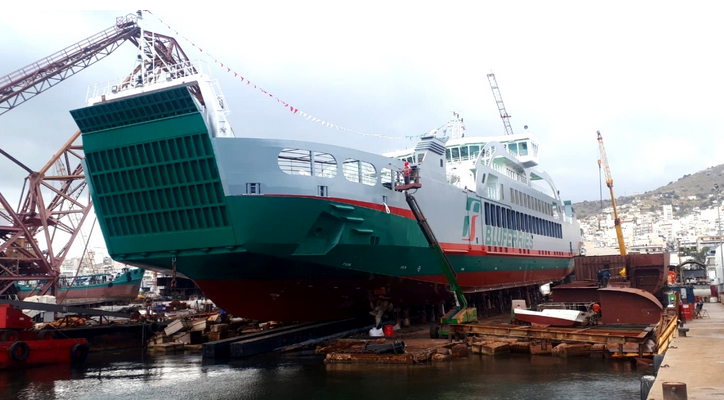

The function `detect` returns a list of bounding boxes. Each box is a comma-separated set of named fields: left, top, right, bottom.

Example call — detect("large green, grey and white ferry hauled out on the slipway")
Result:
left=71, top=36, right=581, bottom=321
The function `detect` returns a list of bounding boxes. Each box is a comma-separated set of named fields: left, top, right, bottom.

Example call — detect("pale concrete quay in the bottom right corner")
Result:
left=648, top=303, right=724, bottom=400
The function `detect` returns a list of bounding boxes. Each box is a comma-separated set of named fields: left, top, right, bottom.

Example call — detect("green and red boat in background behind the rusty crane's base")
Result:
left=17, top=268, right=144, bottom=305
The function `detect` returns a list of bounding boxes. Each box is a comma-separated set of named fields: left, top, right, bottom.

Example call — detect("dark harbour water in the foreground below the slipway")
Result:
left=0, top=351, right=652, bottom=400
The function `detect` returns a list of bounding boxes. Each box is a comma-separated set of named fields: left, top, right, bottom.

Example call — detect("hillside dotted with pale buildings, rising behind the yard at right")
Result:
left=573, top=164, right=724, bottom=219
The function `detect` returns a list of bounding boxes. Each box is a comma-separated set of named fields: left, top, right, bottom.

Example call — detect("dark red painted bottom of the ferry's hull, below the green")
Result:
left=195, top=269, right=567, bottom=322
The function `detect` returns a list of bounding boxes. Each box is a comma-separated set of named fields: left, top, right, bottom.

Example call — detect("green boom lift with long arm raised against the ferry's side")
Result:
left=402, top=189, right=478, bottom=339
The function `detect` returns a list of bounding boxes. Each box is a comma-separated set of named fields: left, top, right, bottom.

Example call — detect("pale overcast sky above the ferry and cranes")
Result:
left=0, top=1, right=724, bottom=256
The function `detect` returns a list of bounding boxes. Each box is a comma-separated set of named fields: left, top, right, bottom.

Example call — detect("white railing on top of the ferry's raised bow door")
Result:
left=86, top=60, right=210, bottom=103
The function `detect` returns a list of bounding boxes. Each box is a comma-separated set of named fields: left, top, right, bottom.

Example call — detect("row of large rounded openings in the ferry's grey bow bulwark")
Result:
left=277, top=149, right=402, bottom=189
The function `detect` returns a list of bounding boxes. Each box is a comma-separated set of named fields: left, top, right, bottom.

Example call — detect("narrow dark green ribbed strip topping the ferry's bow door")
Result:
left=70, top=87, right=198, bottom=134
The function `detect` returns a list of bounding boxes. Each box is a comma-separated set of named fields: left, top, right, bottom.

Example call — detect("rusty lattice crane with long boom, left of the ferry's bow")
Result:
left=0, top=11, right=198, bottom=295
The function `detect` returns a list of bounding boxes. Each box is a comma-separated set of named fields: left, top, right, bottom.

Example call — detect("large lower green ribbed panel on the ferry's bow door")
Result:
left=86, top=134, right=230, bottom=237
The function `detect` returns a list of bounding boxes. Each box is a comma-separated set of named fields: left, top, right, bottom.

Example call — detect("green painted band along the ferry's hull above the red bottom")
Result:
left=107, top=196, right=572, bottom=285
